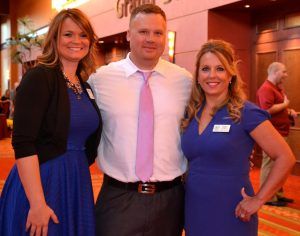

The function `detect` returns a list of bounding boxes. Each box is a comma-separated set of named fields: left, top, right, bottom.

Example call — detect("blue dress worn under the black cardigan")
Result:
left=0, top=89, right=99, bottom=236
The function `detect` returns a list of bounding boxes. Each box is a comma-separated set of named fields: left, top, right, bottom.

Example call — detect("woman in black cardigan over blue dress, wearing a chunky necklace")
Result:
left=0, top=9, right=102, bottom=236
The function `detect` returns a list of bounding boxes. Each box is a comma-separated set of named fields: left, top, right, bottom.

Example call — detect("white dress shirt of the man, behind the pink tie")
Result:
left=88, top=54, right=192, bottom=182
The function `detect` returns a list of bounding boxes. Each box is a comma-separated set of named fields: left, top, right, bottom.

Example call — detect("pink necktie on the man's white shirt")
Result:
left=135, top=72, right=154, bottom=182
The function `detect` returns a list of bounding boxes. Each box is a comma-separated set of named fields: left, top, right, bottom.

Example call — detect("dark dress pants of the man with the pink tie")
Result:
left=95, top=178, right=184, bottom=236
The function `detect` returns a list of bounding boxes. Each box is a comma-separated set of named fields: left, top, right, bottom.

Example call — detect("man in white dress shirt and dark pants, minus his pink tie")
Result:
left=88, top=4, right=192, bottom=236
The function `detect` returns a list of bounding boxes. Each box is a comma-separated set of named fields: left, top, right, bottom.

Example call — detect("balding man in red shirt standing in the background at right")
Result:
left=256, top=62, right=297, bottom=207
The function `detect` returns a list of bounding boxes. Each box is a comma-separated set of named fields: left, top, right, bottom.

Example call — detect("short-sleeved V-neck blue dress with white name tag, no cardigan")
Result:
left=182, top=102, right=268, bottom=236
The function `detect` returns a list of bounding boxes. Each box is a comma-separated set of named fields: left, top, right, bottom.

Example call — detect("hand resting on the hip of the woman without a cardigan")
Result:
left=235, top=188, right=264, bottom=222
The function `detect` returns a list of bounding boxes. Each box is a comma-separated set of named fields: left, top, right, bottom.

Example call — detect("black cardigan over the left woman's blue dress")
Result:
left=12, top=66, right=102, bottom=164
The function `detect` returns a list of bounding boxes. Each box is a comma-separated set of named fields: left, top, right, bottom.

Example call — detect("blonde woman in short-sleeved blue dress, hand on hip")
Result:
left=182, top=40, right=295, bottom=236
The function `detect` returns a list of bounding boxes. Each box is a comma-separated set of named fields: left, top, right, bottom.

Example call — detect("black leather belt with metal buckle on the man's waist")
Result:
left=104, top=175, right=183, bottom=194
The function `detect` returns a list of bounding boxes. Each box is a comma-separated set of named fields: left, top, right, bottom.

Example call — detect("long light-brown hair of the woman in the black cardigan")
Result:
left=37, top=8, right=97, bottom=80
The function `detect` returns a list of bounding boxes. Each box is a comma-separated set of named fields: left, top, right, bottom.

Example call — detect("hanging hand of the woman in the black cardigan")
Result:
left=26, top=204, right=59, bottom=236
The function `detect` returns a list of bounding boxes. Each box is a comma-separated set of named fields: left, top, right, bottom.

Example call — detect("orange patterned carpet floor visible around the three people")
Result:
left=0, top=139, right=300, bottom=236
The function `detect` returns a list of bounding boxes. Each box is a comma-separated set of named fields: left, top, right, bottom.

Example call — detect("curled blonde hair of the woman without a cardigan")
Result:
left=181, top=39, right=246, bottom=131
